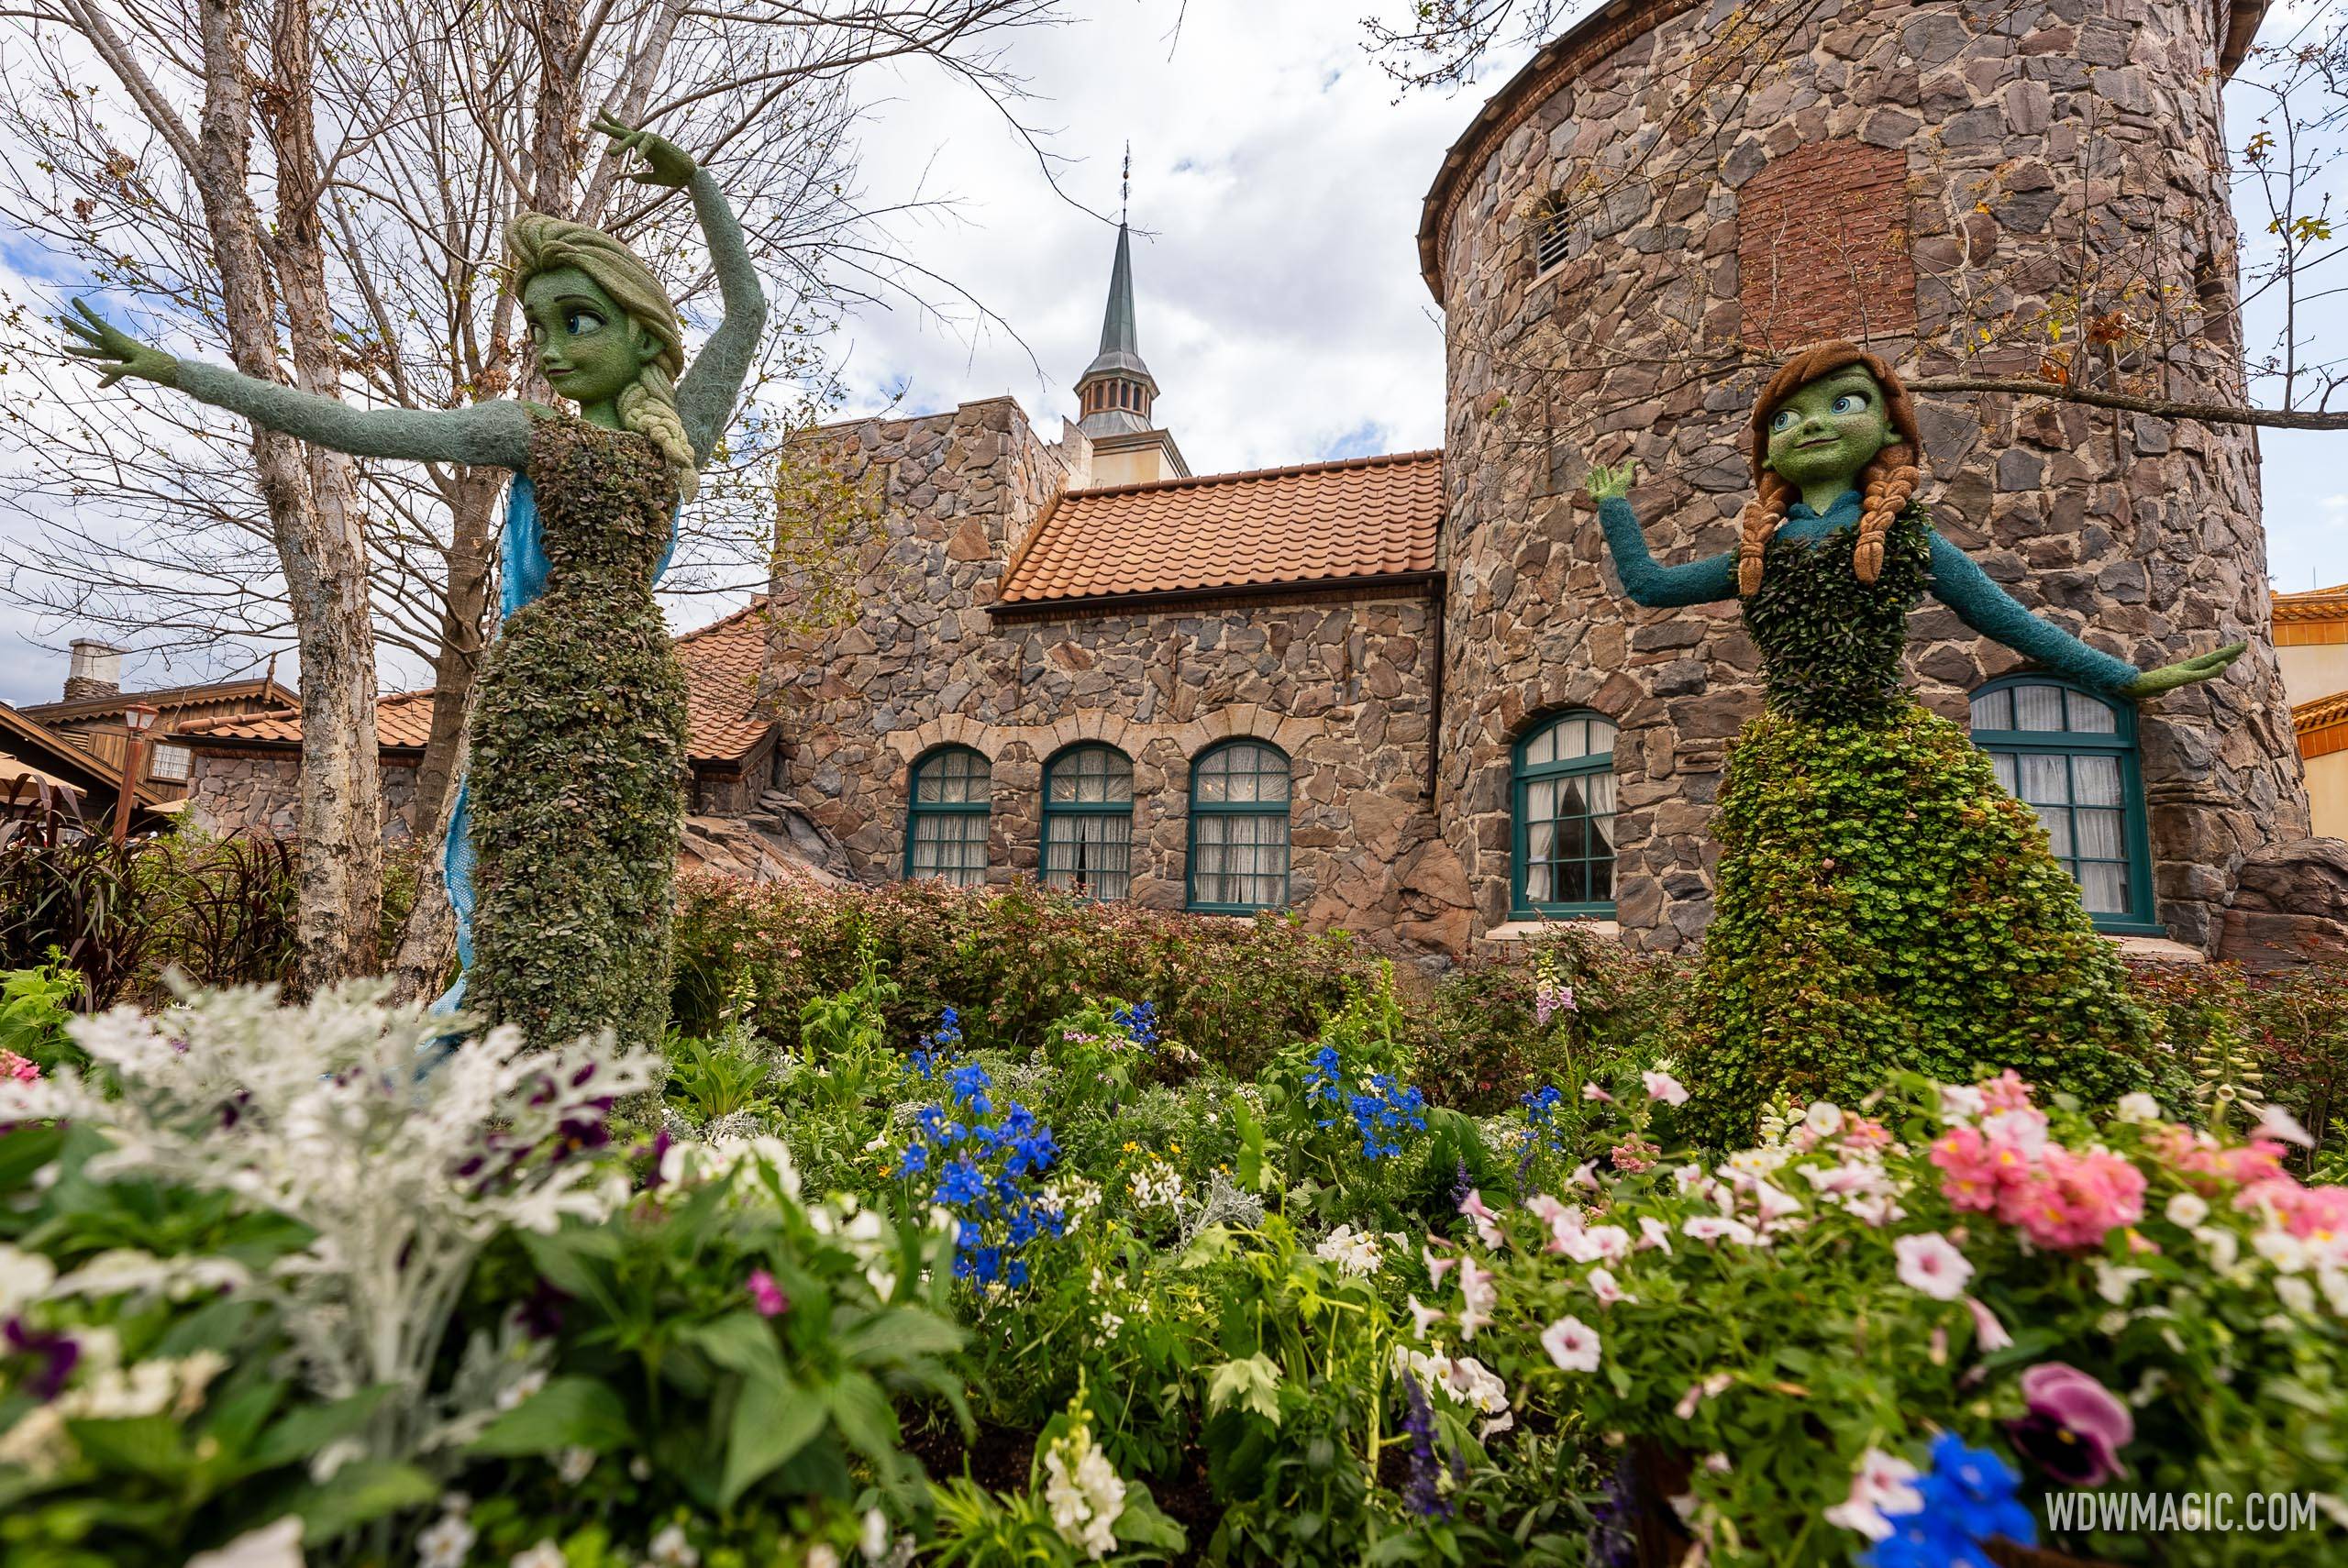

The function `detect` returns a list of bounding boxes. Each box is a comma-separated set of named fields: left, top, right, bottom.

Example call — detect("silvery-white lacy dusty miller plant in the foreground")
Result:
left=0, top=981, right=659, bottom=1446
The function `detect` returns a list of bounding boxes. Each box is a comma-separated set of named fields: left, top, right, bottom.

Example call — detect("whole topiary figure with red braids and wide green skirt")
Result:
left=1589, top=343, right=2243, bottom=1141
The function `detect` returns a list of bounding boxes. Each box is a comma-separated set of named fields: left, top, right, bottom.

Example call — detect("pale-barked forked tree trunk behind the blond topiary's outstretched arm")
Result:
left=193, top=0, right=382, bottom=990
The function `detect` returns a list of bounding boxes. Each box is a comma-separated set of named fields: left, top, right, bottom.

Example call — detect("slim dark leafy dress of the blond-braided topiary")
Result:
left=467, top=418, right=686, bottom=1044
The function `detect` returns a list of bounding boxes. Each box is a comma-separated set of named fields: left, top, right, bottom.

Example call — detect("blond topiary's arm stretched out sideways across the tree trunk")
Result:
left=59, top=301, right=531, bottom=469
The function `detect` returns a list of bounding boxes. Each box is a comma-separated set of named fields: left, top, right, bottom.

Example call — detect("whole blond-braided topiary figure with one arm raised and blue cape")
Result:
left=66, top=120, right=766, bottom=1044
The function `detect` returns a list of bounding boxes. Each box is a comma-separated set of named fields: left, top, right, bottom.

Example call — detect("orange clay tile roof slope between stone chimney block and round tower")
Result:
left=998, top=450, right=1444, bottom=605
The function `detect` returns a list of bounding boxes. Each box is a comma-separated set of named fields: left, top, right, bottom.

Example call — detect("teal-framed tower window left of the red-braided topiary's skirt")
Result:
left=1510, top=713, right=1615, bottom=920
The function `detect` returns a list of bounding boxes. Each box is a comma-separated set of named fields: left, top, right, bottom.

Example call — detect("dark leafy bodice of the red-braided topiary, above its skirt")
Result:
left=1744, top=507, right=1933, bottom=721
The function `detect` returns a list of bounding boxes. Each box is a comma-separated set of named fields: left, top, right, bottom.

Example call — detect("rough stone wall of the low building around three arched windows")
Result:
left=763, top=399, right=1468, bottom=948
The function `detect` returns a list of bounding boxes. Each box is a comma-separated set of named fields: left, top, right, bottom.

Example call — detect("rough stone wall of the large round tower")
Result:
left=1433, top=0, right=2308, bottom=948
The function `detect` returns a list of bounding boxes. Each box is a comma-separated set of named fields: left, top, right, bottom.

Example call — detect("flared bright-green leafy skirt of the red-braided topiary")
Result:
left=1686, top=701, right=2151, bottom=1145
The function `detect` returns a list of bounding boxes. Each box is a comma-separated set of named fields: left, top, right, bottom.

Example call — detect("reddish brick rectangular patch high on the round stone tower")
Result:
left=1737, top=136, right=1916, bottom=349
